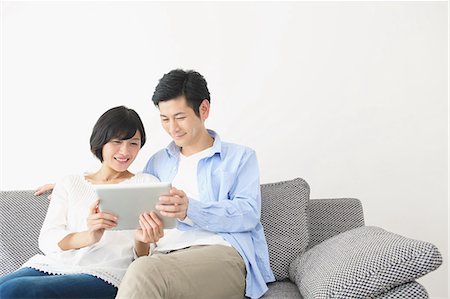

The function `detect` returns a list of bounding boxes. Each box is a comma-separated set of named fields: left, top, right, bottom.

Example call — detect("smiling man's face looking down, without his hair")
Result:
left=159, top=96, right=209, bottom=151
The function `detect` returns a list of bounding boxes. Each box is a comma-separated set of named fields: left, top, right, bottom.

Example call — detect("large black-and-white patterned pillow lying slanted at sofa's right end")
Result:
left=290, top=226, right=442, bottom=298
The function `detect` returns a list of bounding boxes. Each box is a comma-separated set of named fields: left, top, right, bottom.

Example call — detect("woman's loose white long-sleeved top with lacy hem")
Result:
left=22, top=173, right=158, bottom=287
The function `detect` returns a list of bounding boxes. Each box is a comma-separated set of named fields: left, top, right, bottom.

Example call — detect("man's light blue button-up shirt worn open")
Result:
left=144, top=130, right=275, bottom=298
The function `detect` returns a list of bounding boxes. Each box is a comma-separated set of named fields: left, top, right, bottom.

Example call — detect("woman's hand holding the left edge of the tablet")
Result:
left=87, top=199, right=117, bottom=245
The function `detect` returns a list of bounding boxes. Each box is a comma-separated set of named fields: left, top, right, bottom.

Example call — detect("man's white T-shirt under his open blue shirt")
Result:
left=155, top=148, right=231, bottom=252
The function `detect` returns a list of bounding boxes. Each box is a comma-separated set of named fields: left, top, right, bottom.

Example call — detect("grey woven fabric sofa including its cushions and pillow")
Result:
left=0, top=178, right=442, bottom=299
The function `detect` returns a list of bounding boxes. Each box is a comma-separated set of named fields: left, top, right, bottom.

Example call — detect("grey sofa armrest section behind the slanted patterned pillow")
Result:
left=307, top=198, right=364, bottom=249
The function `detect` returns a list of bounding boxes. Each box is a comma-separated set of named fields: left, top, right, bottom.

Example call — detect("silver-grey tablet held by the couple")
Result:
left=94, top=182, right=177, bottom=230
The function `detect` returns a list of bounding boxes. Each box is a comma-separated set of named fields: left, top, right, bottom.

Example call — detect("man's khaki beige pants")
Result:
left=116, top=245, right=246, bottom=299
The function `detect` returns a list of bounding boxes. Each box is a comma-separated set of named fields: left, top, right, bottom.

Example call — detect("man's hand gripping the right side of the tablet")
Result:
left=156, top=187, right=189, bottom=220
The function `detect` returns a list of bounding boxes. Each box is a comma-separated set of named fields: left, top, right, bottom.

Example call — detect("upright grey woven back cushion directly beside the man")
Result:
left=261, top=178, right=309, bottom=280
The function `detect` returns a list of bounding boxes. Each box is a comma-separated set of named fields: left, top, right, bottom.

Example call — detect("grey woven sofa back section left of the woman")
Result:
left=0, top=191, right=49, bottom=276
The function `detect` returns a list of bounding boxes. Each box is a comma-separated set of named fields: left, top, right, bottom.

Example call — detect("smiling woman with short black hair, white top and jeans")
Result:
left=0, top=106, right=163, bottom=298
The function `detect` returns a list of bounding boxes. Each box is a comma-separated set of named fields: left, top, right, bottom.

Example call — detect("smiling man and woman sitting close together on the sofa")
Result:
left=0, top=69, right=275, bottom=298
